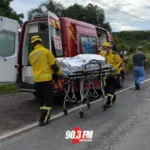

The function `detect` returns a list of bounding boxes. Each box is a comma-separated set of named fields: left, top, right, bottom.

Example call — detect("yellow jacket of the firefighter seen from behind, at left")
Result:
left=29, top=45, right=63, bottom=82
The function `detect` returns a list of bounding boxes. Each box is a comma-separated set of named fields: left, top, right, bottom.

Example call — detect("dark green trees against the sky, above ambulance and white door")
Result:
left=0, top=0, right=111, bottom=32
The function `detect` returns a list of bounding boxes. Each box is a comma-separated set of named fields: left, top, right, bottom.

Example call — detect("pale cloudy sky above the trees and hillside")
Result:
left=11, top=0, right=150, bottom=32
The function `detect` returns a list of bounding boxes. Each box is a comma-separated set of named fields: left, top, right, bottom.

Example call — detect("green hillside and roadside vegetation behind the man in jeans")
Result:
left=112, top=31, right=150, bottom=73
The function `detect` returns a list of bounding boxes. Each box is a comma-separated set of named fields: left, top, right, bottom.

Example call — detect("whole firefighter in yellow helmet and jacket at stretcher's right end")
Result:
left=103, top=42, right=122, bottom=108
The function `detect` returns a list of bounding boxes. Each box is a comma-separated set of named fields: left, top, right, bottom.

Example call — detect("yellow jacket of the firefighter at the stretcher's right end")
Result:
left=105, top=50, right=123, bottom=74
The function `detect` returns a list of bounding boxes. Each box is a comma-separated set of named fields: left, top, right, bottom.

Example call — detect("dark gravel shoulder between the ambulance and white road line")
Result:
left=0, top=71, right=137, bottom=134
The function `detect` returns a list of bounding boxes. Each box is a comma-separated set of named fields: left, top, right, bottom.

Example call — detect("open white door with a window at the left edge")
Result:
left=0, top=16, right=19, bottom=83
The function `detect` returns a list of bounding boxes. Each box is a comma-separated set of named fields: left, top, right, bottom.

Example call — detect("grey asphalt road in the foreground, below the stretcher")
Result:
left=0, top=72, right=150, bottom=150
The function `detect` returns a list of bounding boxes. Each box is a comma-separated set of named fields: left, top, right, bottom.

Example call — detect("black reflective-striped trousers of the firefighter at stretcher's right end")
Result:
left=104, top=75, right=119, bottom=105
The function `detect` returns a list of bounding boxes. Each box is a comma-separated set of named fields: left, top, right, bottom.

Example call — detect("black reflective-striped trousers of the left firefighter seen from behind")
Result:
left=35, top=81, right=54, bottom=123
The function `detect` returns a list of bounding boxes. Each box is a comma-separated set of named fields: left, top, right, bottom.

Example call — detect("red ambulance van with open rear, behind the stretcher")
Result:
left=17, top=12, right=126, bottom=93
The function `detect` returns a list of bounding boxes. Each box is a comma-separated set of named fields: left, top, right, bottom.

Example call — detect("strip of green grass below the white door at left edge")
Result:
left=0, top=84, right=20, bottom=94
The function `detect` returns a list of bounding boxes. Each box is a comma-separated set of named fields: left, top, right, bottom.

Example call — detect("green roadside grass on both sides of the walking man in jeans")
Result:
left=126, top=52, right=150, bottom=73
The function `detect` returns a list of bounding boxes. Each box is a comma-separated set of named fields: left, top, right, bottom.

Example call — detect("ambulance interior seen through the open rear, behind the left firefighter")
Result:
left=22, top=21, right=49, bottom=83
